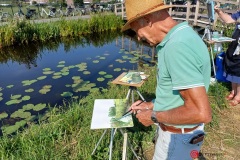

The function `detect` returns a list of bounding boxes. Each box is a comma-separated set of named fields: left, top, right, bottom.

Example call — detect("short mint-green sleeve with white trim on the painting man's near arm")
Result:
left=165, top=42, right=204, bottom=90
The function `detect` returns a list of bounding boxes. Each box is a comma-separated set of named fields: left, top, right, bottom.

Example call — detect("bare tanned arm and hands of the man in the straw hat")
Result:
left=131, top=87, right=212, bottom=126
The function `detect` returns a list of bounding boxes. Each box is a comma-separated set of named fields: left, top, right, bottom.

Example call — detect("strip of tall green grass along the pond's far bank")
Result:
left=0, top=13, right=122, bottom=47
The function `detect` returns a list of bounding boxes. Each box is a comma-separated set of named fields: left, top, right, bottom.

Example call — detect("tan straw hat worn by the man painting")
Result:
left=122, top=0, right=172, bottom=31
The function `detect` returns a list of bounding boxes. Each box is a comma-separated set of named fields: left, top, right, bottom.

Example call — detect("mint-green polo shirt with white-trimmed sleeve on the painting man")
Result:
left=154, top=22, right=211, bottom=128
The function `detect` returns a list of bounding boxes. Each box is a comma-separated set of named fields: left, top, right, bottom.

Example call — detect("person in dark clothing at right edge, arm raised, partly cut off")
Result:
left=214, top=6, right=240, bottom=106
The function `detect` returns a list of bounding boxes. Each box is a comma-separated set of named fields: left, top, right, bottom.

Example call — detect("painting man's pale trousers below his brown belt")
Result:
left=153, top=124, right=204, bottom=160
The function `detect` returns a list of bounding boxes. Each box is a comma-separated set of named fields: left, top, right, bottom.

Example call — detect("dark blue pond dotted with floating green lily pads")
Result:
left=0, top=31, right=154, bottom=133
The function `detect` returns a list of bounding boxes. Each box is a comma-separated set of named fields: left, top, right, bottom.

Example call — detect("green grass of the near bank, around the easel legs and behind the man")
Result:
left=0, top=67, right=236, bottom=160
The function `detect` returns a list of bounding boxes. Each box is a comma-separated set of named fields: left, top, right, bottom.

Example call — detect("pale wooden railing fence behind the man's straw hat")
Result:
left=115, top=0, right=240, bottom=28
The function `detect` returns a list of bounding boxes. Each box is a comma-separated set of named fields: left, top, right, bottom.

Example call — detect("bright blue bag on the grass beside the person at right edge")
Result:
left=215, top=52, right=229, bottom=82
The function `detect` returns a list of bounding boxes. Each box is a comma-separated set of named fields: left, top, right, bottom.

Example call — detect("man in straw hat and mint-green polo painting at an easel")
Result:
left=122, top=0, right=212, bottom=160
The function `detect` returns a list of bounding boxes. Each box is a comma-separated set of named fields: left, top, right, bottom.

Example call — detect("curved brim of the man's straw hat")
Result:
left=122, top=5, right=173, bottom=32
